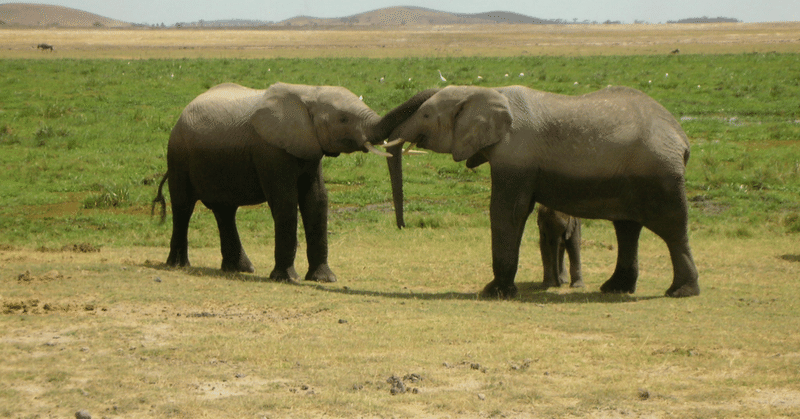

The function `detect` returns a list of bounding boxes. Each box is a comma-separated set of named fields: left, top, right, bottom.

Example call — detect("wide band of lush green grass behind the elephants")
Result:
left=0, top=54, right=800, bottom=246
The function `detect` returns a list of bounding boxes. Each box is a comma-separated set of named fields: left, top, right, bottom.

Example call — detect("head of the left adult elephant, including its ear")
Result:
left=250, top=83, right=388, bottom=160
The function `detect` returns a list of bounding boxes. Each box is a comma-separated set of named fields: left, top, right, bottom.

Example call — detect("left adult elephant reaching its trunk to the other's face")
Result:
left=153, top=83, right=421, bottom=282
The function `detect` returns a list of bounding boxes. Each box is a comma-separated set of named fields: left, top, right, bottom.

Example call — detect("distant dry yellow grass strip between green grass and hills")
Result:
left=0, top=22, right=800, bottom=59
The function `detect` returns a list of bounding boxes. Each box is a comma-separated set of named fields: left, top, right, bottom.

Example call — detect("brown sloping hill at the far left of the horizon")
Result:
left=0, top=3, right=131, bottom=28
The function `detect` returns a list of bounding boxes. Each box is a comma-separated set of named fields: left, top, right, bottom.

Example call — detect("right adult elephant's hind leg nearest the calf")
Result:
left=600, top=221, right=642, bottom=294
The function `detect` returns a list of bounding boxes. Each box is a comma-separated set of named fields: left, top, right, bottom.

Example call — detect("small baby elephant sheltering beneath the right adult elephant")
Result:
left=536, top=204, right=583, bottom=288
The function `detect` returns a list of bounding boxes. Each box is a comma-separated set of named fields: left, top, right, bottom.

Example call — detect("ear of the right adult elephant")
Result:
left=453, top=88, right=511, bottom=163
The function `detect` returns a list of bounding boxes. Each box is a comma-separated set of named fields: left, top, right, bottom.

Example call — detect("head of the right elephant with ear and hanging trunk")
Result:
left=388, top=86, right=511, bottom=228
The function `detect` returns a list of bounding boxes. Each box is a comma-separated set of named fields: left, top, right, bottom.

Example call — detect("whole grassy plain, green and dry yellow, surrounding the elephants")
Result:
left=0, top=28, right=800, bottom=418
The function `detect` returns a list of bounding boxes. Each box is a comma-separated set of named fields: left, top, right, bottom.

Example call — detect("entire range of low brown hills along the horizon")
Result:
left=0, top=3, right=739, bottom=28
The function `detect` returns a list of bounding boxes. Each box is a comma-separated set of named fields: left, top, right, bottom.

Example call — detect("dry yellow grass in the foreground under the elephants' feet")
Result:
left=0, top=223, right=800, bottom=418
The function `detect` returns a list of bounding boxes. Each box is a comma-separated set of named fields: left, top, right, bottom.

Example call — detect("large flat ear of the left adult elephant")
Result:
left=250, top=92, right=322, bottom=160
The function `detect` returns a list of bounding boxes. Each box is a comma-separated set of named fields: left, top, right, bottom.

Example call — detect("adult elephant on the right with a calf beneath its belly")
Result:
left=389, top=86, right=700, bottom=297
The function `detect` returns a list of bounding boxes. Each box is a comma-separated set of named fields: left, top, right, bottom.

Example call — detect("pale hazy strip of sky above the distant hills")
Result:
left=14, top=0, right=800, bottom=25
